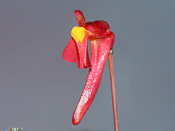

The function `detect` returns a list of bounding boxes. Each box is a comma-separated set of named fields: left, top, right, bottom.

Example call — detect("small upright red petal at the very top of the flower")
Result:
left=74, top=10, right=86, bottom=27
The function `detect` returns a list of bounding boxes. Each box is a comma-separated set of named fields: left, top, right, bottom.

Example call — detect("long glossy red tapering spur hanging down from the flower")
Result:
left=72, top=32, right=114, bottom=125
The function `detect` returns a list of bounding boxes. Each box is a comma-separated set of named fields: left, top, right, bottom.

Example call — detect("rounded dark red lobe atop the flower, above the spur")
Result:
left=85, top=20, right=110, bottom=35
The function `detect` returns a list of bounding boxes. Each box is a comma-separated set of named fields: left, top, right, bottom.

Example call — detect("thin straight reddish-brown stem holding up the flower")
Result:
left=108, top=49, right=119, bottom=131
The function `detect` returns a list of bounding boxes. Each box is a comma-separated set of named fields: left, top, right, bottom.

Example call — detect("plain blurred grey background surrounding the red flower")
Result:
left=0, top=0, right=175, bottom=131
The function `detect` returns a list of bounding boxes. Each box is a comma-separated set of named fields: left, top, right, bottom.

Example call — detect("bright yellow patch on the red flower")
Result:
left=71, top=26, right=88, bottom=43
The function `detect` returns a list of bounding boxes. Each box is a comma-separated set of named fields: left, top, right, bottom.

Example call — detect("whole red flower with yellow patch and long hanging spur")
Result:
left=63, top=10, right=115, bottom=125
